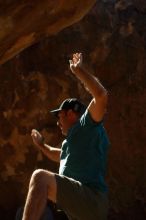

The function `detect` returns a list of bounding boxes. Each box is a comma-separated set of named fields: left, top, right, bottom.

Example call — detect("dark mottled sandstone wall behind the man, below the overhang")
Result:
left=0, top=0, right=146, bottom=220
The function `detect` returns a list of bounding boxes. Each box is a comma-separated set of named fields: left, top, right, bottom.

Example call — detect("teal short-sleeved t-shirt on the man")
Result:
left=59, top=110, right=109, bottom=192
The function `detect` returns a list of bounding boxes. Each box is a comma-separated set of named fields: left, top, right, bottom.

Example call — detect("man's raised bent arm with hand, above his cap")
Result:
left=70, top=53, right=107, bottom=122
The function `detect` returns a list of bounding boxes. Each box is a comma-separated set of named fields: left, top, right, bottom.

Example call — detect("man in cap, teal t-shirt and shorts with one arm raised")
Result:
left=23, top=53, right=109, bottom=220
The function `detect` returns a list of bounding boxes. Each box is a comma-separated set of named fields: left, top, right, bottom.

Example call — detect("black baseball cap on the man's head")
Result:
left=50, top=98, right=86, bottom=116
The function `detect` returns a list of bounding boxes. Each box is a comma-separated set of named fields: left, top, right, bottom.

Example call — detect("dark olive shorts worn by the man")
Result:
left=56, top=174, right=108, bottom=220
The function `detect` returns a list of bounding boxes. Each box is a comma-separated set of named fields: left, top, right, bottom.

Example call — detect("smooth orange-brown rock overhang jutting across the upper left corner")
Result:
left=0, top=0, right=95, bottom=64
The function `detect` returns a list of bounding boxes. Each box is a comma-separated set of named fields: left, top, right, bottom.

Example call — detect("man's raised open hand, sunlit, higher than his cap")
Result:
left=69, top=53, right=83, bottom=73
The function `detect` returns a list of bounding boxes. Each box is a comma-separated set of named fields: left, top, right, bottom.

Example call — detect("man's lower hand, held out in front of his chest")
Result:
left=31, top=129, right=44, bottom=148
